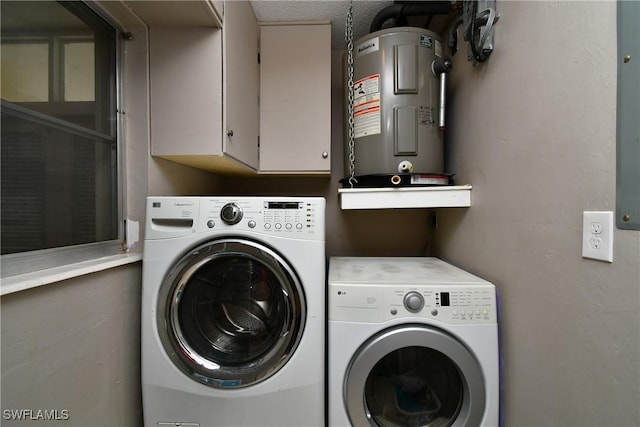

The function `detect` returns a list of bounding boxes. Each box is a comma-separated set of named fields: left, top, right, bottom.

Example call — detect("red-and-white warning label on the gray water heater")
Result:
left=353, top=74, right=381, bottom=138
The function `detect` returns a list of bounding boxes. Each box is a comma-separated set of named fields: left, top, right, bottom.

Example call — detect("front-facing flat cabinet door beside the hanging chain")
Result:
left=260, top=24, right=331, bottom=174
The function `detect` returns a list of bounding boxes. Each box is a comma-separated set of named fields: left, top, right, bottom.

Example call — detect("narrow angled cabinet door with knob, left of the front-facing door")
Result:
left=223, top=1, right=259, bottom=169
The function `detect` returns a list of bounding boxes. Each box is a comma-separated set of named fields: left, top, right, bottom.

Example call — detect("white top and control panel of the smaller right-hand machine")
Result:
left=328, top=257, right=497, bottom=324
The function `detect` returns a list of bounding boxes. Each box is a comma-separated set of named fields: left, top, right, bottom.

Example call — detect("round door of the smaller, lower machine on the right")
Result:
left=345, top=325, right=485, bottom=427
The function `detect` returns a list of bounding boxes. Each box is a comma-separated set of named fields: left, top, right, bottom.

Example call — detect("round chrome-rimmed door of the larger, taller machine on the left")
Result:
left=158, top=239, right=305, bottom=388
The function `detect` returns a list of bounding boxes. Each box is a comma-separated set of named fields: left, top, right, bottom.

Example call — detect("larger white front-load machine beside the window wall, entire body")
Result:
left=141, top=197, right=326, bottom=427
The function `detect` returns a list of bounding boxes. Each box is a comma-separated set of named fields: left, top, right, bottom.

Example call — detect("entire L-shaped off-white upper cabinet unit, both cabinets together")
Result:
left=127, top=0, right=331, bottom=175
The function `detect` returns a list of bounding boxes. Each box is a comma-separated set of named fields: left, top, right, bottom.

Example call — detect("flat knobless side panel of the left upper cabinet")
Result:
left=149, top=27, right=222, bottom=159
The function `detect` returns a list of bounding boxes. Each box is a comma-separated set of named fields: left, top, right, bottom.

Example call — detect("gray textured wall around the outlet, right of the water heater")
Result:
left=435, top=1, right=640, bottom=426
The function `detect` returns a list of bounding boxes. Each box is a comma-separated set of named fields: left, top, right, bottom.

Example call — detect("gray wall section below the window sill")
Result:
left=1, top=263, right=142, bottom=427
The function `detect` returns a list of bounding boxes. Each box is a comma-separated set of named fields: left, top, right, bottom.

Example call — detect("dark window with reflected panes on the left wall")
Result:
left=0, top=0, right=122, bottom=275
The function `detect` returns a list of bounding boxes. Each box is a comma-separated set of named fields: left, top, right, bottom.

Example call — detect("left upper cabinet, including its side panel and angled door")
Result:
left=144, top=1, right=258, bottom=173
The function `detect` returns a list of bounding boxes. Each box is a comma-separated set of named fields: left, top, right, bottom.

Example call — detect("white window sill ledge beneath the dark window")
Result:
left=0, top=253, right=142, bottom=296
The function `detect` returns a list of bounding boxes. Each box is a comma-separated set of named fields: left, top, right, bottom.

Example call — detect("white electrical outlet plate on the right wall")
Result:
left=582, top=211, right=613, bottom=262
